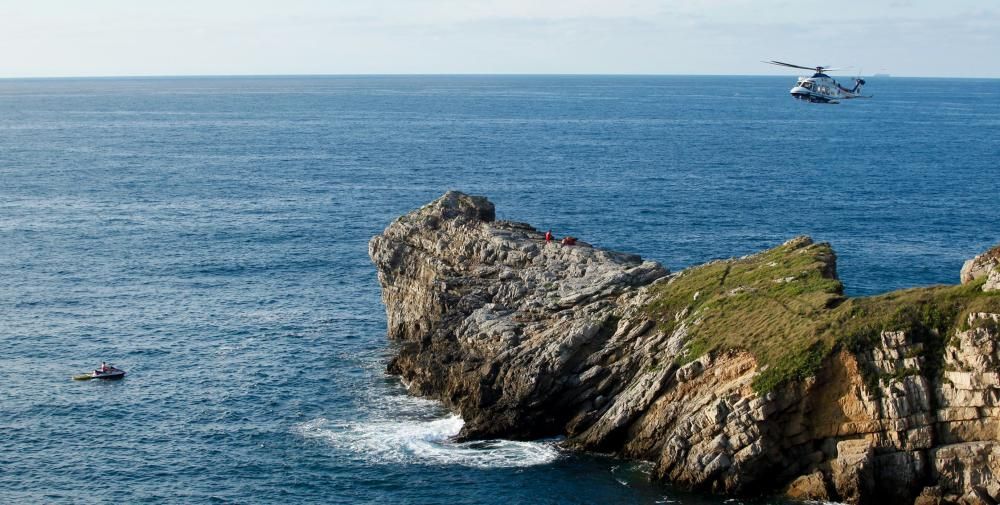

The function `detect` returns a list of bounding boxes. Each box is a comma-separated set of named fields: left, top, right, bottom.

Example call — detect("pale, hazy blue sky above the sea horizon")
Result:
left=0, top=0, right=1000, bottom=77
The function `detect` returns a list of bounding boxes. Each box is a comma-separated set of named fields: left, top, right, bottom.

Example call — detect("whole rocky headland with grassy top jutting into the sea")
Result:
left=369, top=192, right=1000, bottom=503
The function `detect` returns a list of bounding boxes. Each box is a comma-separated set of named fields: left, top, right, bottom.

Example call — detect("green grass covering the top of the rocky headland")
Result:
left=647, top=239, right=1000, bottom=393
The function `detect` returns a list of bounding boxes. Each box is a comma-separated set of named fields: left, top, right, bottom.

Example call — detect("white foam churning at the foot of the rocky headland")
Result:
left=297, top=415, right=559, bottom=468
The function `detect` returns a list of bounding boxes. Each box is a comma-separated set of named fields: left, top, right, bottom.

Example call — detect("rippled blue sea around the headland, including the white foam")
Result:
left=0, top=75, right=1000, bottom=505
